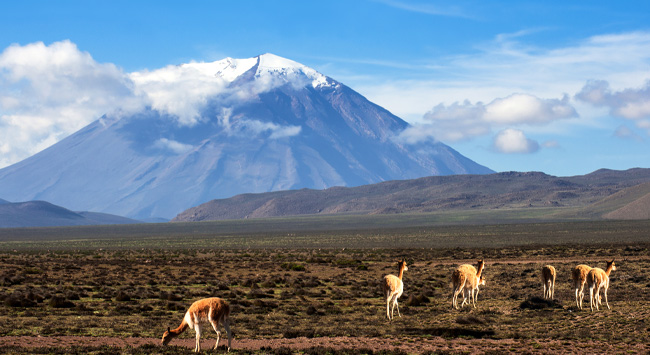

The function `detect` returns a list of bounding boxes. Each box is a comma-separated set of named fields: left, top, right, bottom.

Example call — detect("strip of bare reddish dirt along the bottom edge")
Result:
left=0, top=336, right=650, bottom=354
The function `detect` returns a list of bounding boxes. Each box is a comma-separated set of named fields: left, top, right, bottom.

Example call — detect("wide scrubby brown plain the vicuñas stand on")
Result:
left=0, top=217, right=650, bottom=354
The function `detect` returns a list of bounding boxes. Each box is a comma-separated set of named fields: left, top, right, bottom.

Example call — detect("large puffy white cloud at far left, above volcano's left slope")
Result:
left=0, top=41, right=139, bottom=167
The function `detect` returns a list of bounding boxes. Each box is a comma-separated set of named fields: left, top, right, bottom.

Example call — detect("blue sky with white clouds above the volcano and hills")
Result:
left=0, top=0, right=650, bottom=176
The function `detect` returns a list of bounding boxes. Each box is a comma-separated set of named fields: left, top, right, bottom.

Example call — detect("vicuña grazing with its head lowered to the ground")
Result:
left=162, top=297, right=232, bottom=352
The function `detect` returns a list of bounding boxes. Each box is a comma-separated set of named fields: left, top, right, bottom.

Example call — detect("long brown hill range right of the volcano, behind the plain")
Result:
left=172, top=168, right=650, bottom=221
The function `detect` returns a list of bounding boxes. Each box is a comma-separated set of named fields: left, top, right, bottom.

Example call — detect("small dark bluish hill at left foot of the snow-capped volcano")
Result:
left=0, top=200, right=142, bottom=228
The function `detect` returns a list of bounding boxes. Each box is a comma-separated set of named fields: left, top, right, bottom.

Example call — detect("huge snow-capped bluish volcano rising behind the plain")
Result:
left=0, top=54, right=492, bottom=219
